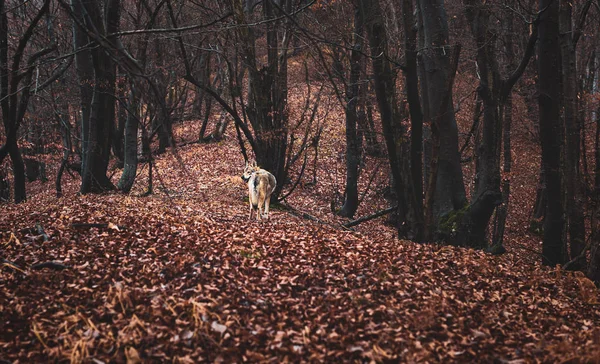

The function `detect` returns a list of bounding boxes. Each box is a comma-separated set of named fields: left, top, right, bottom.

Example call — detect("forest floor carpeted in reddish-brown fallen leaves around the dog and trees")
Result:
left=0, top=113, right=600, bottom=363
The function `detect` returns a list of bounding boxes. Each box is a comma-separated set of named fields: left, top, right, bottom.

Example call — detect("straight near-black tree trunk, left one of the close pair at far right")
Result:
left=538, top=0, right=566, bottom=266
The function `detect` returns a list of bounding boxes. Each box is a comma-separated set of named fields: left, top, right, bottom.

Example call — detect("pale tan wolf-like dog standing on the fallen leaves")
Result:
left=242, top=161, right=277, bottom=220
